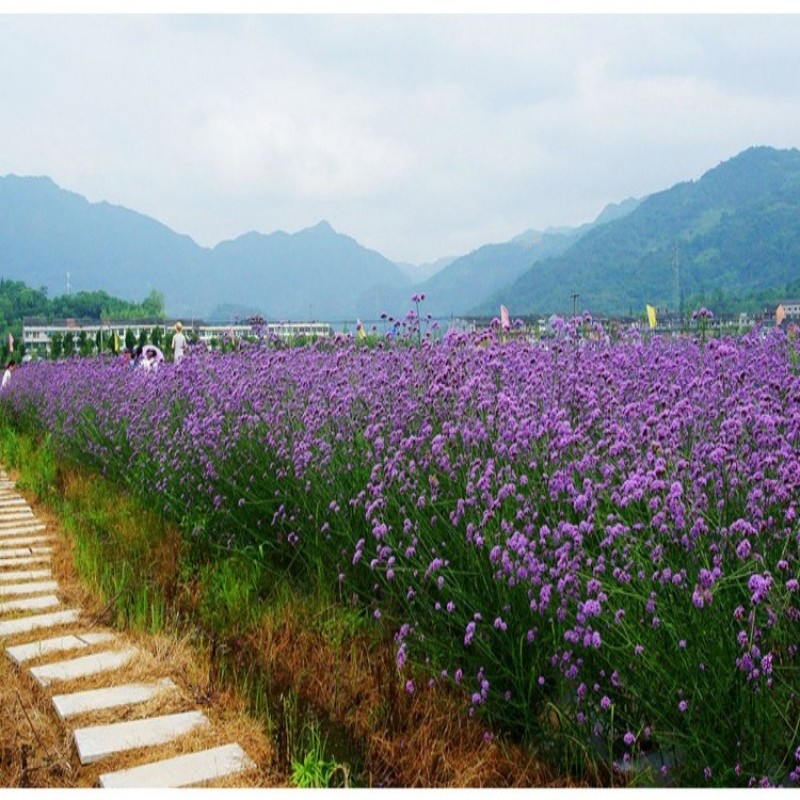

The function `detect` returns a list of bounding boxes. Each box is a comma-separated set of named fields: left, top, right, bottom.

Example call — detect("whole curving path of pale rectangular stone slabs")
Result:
left=0, top=468, right=257, bottom=789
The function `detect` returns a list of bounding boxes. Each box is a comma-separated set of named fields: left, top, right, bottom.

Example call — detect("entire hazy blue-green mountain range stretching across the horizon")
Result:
left=0, top=147, right=800, bottom=322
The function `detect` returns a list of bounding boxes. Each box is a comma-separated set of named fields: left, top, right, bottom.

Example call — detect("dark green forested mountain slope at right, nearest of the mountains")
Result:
left=479, top=147, right=800, bottom=315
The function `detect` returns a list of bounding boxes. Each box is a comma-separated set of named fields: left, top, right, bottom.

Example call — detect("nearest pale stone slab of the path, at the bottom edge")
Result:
left=100, top=744, right=256, bottom=789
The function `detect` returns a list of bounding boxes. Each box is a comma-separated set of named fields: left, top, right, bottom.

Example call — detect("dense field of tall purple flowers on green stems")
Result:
left=0, top=326, right=800, bottom=786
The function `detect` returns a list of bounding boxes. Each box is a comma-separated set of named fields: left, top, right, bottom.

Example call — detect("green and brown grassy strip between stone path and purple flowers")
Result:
left=0, top=429, right=565, bottom=787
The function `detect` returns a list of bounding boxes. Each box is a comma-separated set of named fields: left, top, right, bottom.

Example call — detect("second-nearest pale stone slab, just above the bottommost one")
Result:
left=73, top=711, right=208, bottom=764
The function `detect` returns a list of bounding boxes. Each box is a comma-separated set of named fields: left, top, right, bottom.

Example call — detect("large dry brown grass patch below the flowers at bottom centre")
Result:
left=231, top=611, right=579, bottom=788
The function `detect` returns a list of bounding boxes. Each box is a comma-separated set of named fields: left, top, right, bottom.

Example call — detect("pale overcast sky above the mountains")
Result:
left=0, top=8, right=800, bottom=263
